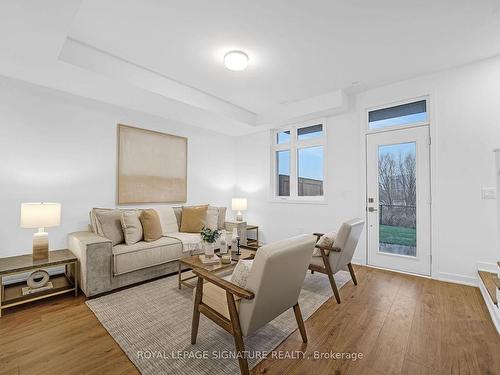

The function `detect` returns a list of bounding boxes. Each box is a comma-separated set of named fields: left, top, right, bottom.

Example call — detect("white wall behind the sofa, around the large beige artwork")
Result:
left=0, top=78, right=235, bottom=257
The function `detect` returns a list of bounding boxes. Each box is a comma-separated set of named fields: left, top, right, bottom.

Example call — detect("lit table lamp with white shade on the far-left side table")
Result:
left=21, top=202, right=61, bottom=260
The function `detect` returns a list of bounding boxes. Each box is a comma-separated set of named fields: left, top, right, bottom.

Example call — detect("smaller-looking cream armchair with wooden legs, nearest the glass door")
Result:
left=309, top=218, right=365, bottom=303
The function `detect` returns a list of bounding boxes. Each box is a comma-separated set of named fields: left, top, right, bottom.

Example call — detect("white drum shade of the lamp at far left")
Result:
left=21, top=203, right=61, bottom=228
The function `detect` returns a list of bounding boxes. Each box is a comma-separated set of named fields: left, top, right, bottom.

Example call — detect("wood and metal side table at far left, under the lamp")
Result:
left=0, top=249, right=78, bottom=317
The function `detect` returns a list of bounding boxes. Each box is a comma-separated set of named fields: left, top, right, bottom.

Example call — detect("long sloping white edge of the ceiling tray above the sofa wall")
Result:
left=59, top=37, right=257, bottom=126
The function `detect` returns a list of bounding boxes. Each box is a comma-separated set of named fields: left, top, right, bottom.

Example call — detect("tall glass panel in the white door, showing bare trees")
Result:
left=378, top=142, right=417, bottom=257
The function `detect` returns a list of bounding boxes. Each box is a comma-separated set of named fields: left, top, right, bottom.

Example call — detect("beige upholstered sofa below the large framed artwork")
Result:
left=68, top=207, right=246, bottom=297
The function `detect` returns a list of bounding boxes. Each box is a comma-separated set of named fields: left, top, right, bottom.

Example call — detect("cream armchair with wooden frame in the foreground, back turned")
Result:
left=191, top=235, right=316, bottom=374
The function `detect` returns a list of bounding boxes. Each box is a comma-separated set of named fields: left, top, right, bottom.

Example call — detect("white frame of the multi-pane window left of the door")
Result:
left=270, top=118, right=328, bottom=204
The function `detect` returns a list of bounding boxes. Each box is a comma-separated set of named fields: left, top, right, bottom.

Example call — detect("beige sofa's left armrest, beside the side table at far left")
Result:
left=68, top=232, right=112, bottom=297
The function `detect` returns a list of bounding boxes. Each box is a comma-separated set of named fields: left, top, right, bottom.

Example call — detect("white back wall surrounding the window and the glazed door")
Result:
left=237, top=58, right=500, bottom=284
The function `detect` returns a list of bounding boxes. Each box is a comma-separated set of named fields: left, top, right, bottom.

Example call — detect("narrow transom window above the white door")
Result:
left=368, top=99, right=428, bottom=130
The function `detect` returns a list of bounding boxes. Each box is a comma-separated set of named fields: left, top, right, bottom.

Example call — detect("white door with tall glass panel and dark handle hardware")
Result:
left=366, top=126, right=431, bottom=275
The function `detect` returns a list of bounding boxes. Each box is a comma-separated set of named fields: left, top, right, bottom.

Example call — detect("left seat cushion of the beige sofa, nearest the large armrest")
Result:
left=112, top=237, right=182, bottom=276
